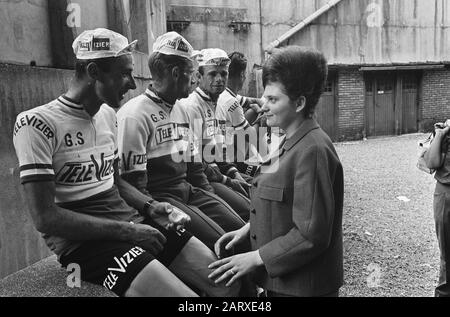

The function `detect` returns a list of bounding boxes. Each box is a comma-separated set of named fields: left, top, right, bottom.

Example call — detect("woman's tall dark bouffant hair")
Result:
left=263, top=46, right=328, bottom=117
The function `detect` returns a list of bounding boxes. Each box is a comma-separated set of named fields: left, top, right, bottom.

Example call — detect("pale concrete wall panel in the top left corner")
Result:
left=0, top=0, right=52, bottom=66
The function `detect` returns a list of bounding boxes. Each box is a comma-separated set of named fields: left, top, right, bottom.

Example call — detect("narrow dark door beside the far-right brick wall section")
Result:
left=402, top=73, right=419, bottom=133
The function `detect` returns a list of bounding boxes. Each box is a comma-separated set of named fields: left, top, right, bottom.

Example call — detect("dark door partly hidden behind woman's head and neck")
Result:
left=316, top=74, right=337, bottom=140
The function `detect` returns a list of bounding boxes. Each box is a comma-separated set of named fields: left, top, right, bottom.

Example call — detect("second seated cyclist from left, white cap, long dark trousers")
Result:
left=117, top=32, right=245, bottom=250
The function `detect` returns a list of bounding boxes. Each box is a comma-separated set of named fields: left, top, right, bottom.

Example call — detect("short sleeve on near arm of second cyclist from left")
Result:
left=118, top=117, right=150, bottom=174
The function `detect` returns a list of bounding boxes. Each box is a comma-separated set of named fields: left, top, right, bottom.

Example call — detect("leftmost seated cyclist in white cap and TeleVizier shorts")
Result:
left=13, top=29, right=239, bottom=297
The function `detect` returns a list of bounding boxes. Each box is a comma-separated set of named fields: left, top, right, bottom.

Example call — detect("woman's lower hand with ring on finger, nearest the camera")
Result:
left=208, top=250, right=264, bottom=287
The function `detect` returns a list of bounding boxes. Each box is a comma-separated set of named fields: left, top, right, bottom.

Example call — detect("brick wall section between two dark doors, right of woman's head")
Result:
left=338, top=69, right=365, bottom=141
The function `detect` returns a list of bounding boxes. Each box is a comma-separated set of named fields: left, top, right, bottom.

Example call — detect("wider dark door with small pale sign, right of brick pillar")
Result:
left=366, top=73, right=396, bottom=136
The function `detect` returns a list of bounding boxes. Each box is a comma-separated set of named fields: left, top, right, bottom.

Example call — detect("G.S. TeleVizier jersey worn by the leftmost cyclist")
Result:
left=13, top=97, right=118, bottom=203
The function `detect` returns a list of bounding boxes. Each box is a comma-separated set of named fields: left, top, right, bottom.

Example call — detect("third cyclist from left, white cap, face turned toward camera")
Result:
left=181, top=49, right=255, bottom=220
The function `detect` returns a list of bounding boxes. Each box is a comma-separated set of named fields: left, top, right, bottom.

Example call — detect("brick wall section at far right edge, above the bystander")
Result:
left=419, top=69, right=450, bottom=131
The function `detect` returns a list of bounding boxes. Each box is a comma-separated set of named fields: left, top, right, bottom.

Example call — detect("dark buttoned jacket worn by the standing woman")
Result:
left=250, top=119, right=344, bottom=297
